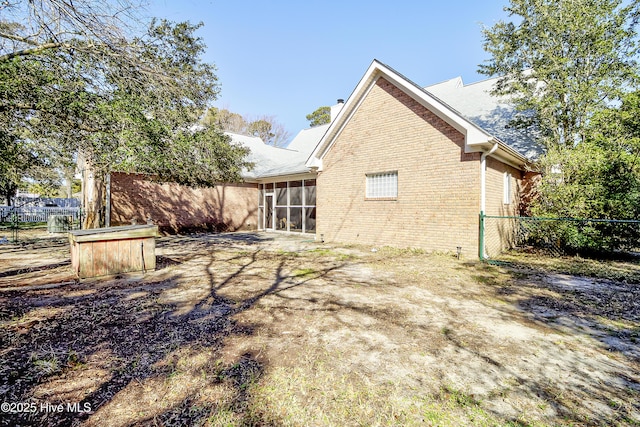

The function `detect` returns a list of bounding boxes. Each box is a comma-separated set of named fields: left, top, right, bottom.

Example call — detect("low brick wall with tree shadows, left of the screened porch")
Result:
left=111, top=173, right=258, bottom=233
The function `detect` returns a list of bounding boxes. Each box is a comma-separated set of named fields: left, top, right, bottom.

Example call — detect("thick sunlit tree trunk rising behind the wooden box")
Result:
left=79, top=156, right=106, bottom=229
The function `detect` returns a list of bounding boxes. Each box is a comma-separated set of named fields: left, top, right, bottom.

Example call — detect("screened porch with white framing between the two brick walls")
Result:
left=258, top=179, right=316, bottom=233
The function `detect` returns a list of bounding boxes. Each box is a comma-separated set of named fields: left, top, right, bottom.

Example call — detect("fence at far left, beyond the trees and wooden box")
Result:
left=0, top=206, right=83, bottom=244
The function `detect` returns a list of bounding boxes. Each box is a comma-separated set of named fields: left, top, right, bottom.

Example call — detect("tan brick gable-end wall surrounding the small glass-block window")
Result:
left=317, top=78, right=482, bottom=256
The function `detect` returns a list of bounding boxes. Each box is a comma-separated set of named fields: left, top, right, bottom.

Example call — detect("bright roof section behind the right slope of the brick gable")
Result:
left=424, top=77, right=542, bottom=159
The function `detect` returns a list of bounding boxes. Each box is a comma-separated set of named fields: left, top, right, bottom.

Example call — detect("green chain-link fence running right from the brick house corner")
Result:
left=478, top=213, right=640, bottom=260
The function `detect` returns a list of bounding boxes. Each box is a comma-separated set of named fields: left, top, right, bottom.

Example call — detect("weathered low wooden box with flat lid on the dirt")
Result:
left=69, top=225, right=158, bottom=279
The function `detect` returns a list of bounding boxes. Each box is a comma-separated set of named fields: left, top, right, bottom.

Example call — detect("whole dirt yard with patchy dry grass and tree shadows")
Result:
left=0, top=234, right=640, bottom=426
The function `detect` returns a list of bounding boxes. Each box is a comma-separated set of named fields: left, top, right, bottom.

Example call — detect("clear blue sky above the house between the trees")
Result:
left=148, top=0, right=508, bottom=143
